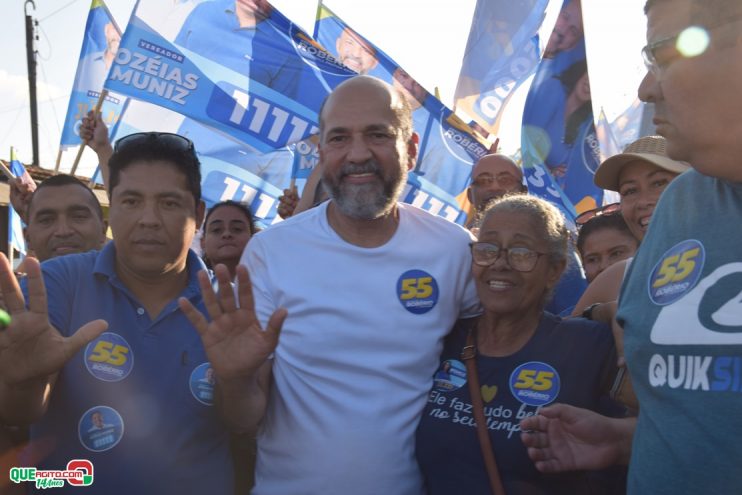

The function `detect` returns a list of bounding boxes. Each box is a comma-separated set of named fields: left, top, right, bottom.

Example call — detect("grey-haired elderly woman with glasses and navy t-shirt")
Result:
left=417, top=195, right=618, bottom=494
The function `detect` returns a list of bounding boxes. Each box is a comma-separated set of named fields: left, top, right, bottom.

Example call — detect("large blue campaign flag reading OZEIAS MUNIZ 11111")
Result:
left=106, top=0, right=354, bottom=153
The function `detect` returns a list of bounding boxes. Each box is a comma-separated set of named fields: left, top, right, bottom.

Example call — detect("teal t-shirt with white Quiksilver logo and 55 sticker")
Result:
left=616, top=170, right=742, bottom=495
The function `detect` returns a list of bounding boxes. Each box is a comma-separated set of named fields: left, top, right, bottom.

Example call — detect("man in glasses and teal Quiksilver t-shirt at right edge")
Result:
left=522, top=0, right=742, bottom=494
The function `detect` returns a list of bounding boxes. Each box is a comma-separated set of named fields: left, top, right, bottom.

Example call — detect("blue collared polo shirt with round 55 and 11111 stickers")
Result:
left=24, top=242, right=233, bottom=495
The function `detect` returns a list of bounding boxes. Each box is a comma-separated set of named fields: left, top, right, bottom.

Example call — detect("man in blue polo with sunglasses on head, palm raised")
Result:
left=0, top=133, right=233, bottom=494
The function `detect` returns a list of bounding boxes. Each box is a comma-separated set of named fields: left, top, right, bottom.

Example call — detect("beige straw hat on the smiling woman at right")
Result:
left=593, top=136, right=690, bottom=191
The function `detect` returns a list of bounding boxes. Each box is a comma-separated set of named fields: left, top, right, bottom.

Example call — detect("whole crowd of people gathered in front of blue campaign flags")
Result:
left=0, top=0, right=742, bottom=495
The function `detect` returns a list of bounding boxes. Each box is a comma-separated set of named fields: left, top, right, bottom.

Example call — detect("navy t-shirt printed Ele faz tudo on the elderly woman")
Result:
left=416, top=313, right=615, bottom=495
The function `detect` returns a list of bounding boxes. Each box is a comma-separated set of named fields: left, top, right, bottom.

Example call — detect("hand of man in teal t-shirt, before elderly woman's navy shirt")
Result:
left=520, top=404, right=636, bottom=473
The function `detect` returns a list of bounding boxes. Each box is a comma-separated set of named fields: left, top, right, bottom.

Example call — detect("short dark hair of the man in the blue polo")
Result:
left=108, top=132, right=201, bottom=206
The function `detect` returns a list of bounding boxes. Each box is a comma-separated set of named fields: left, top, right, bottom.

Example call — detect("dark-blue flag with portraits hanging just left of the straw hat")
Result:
left=521, top=0, right=603, bottom=215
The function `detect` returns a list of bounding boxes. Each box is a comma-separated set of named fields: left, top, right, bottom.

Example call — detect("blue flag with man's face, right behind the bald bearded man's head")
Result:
left=314, top=2, right=488, bottom=217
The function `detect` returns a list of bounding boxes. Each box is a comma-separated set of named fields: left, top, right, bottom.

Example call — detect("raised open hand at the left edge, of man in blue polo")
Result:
left=0, top=253, right=108, bottom=388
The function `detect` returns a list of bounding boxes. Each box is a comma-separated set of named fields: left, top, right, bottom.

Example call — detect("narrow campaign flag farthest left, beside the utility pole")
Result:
left=60, top=0, right=126, bottom=149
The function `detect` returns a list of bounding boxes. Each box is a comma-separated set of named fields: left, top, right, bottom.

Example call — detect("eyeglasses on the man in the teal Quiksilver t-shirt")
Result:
left=642, top=14, right=742, bottom=76
